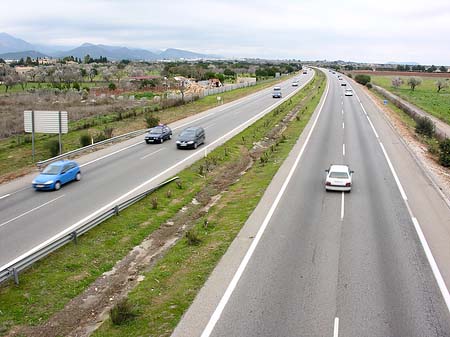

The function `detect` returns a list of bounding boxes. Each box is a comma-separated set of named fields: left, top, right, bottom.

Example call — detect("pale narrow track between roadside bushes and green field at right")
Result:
left=372, top=85, right=450, bottom=140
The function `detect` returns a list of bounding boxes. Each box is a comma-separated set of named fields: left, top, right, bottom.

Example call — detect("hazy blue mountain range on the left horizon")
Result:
left=0, top=33, right=222, bottom=61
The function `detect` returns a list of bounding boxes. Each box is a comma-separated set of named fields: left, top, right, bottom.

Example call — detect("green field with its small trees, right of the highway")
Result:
left=372, top=75, right=450, bottom=124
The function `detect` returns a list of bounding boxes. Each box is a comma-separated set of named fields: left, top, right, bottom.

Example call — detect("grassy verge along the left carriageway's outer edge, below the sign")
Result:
left=0, top=79, right=286, bottom=182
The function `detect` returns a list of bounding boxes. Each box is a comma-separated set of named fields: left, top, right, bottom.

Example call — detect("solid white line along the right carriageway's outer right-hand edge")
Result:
left=361, top=90, right=450, bottom=312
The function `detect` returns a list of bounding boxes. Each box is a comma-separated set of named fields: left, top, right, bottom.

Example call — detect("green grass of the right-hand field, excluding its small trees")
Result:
left=371, top=76, right=450, bottom=124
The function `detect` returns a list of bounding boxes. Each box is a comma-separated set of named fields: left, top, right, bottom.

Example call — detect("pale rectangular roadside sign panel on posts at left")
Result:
left=23, top=110, right=69, bottom=133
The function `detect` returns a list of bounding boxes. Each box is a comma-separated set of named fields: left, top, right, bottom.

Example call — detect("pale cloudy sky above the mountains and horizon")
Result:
left=0, top=0, right=450, bottom=65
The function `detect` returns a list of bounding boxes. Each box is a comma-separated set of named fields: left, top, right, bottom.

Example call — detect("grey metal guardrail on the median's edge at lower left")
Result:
left=0, top=176, right=178, bottom=284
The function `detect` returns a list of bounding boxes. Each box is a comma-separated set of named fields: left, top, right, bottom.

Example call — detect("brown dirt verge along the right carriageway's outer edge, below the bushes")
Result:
left=364, top=88, right=450, bottom=200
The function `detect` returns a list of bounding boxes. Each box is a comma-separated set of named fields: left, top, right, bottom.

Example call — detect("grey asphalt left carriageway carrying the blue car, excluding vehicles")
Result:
left=0, top=71, right=313, bottom=269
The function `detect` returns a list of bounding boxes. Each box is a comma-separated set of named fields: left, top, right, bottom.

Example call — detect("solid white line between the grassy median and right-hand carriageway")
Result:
left=201, top=72, right=329, bottom=337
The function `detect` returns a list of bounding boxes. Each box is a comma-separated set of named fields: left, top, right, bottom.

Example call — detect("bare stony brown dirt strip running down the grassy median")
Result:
left=7, top=90, right=301, bottom=337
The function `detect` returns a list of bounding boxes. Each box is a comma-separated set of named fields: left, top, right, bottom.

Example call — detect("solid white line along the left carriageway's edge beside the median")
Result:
left=0, top=76, right=314, bottom=270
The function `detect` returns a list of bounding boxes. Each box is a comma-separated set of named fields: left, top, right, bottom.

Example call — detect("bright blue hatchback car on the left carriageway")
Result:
left=32, top=160, right=81, bottom=191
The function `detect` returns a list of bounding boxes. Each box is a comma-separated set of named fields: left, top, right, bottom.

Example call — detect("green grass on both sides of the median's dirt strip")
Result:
left=0, top=72, right=325, bottom=336
